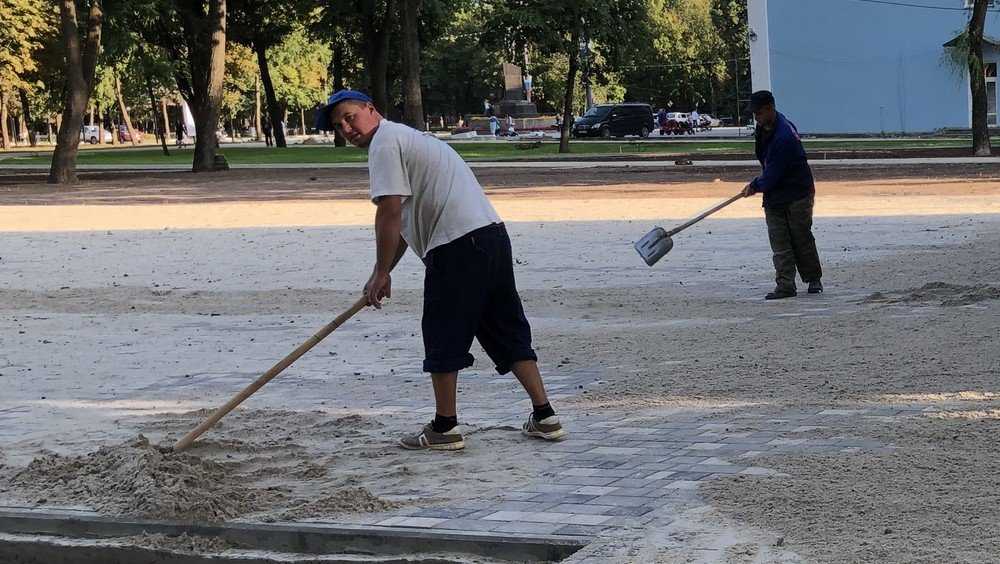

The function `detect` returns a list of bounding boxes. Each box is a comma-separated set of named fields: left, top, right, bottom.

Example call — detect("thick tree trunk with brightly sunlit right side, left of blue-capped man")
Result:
left=177, top=0, right=226, bottom=172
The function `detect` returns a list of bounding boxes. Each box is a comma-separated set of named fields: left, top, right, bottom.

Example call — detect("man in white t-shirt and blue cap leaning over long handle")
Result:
left=317, top=90, right=566, bottom=450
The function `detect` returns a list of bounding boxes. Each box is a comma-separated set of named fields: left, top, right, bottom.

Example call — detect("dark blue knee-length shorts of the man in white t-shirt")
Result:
left=422, top=223, right=538, bottom=374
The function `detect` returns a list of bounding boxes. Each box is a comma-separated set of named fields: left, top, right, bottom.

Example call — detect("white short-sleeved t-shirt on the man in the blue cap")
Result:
left=368, top=119, right=500, bottom=258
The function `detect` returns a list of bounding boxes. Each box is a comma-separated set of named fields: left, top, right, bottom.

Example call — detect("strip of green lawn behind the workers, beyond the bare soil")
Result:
left=0, top=139, right=988, bottom=166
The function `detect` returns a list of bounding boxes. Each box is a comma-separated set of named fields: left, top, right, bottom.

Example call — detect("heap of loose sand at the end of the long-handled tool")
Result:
left=11, top=435, right=281, bottom=521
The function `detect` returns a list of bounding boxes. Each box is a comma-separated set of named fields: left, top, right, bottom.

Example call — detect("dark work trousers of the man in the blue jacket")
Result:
left=764, top=196, right=823, bottom=290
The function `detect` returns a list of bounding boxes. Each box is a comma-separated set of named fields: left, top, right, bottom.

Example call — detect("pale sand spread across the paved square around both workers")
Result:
left=0, top=166, right=1000, bottom=562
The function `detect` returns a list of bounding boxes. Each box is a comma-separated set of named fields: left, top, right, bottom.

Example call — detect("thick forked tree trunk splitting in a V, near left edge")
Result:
left=49, top=0, right=104, bottom=184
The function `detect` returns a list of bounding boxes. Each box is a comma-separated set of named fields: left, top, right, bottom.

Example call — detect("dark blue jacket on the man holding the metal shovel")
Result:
left=750, top=113, right=816, bottom=208
